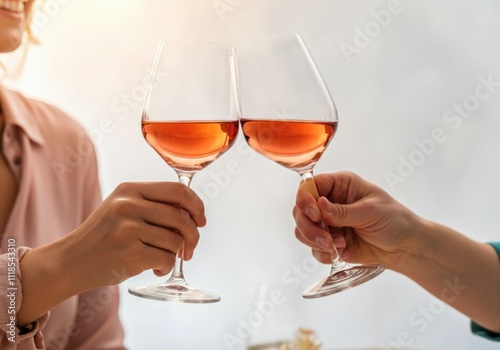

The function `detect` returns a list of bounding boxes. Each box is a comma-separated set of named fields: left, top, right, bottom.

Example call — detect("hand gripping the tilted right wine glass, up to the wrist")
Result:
left=293, top=172, right=420, bottom=268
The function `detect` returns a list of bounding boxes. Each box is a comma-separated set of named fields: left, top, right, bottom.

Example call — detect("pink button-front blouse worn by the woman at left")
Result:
left=0, top=86, right=124, bottom=350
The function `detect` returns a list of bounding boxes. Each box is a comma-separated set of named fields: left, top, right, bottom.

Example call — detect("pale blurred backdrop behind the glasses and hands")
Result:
left=4, top=0, right=500, bottom=350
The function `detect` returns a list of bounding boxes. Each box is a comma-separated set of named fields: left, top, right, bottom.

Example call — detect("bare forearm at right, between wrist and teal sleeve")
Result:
left=394, top=220, right=500, bottom=333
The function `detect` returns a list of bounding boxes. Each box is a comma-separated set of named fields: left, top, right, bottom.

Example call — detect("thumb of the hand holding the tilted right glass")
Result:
left=318, top=197, right=363, bottom=227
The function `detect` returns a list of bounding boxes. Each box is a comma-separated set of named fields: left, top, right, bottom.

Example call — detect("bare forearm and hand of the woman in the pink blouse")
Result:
left=17, top=183, right=205, bottom=326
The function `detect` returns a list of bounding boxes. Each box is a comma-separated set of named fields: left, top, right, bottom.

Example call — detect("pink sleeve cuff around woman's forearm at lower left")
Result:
left=0, top=247, right=49, bottom=350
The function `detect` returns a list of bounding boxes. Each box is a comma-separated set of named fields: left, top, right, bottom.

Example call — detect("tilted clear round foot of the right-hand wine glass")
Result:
left=302, top=264, right=385, bottom=299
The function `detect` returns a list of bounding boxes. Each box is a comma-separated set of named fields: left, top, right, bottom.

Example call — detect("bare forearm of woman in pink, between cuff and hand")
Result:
left=17, top=238, right=83, bottom=327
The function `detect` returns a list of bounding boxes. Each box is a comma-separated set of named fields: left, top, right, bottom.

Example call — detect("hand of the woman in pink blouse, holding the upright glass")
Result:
left=66, top=183, right=206, bottom=288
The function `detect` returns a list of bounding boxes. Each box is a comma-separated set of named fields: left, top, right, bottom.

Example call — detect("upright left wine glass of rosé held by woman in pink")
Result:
left=129, top=39, right=239, bottom=303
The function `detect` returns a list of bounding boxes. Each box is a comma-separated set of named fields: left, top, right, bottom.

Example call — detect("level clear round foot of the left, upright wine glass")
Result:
left=128, top=282, right=220, bottom=304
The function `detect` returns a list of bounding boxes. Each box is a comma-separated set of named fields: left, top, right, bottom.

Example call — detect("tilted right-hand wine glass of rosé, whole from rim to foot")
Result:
left=237, top=34, right=384, bottom=298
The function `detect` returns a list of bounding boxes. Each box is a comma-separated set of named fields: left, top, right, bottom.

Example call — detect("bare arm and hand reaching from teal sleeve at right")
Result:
left=294, top=172, right=500, bottom=333
